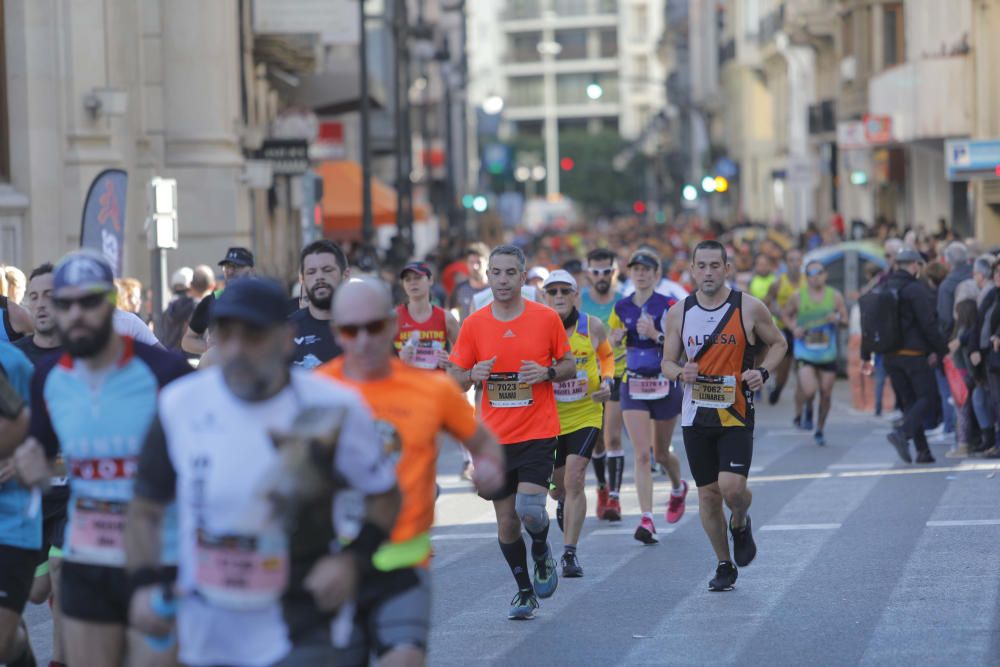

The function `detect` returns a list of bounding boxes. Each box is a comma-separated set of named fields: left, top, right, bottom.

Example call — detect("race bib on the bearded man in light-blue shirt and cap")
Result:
left=69, top=498, right=127, bottom=565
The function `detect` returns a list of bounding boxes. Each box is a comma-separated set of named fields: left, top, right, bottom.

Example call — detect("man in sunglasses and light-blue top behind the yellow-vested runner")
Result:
left=580, top=248, right=625, bottom=521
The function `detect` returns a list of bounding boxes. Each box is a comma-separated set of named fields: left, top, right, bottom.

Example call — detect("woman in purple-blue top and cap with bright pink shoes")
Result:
left=611, top=250, right=688, bottom=544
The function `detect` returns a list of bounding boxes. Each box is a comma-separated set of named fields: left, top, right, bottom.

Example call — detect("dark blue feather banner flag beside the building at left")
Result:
left=80, top=169, right=128, bottom=277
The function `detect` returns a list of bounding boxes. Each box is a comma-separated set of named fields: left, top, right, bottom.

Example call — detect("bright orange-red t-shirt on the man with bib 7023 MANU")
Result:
left=451, top=300, right=570, bottom=445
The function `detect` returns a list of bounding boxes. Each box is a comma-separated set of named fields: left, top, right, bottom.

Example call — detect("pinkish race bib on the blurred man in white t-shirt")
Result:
left=195, top=530, right=288, bottom=611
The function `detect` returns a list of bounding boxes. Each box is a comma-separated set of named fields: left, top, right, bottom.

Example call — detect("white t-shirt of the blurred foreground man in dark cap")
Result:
left=160, top=368, right=396, bottom=667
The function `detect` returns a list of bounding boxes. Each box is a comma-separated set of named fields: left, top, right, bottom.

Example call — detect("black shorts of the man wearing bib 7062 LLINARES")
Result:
left=684, top=426, right=753, bottom=486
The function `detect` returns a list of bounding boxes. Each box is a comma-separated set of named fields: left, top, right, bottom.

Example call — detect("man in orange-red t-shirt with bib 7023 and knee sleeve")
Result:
left=449, top=245, right=576, bottom=620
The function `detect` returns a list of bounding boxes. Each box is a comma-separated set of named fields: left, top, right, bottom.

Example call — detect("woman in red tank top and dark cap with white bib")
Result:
left=394, top=262, right=458, bottom=369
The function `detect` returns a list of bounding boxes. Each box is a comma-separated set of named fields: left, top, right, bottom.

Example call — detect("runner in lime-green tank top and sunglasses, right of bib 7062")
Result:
left=785, top=261, right=847, bottom=446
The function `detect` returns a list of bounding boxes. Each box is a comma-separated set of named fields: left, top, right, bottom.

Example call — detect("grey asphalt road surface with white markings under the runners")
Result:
left=27, top=383, right=1000, bottom=667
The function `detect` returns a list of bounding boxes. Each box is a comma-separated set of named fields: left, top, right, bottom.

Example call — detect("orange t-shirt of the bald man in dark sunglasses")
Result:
left=316, top=357, right=477, bottom=560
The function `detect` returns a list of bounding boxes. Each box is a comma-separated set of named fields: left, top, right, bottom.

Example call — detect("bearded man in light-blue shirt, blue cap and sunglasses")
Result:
left=14, top=250, right=191, bottom=667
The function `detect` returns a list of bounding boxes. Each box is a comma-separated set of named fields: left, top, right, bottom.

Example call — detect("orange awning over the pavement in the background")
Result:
left=315, top=160, right=427, bottom=238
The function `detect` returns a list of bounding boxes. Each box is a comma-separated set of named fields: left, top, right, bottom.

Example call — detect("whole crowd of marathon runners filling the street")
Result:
left=0, top=217, right=984, bottom=667
